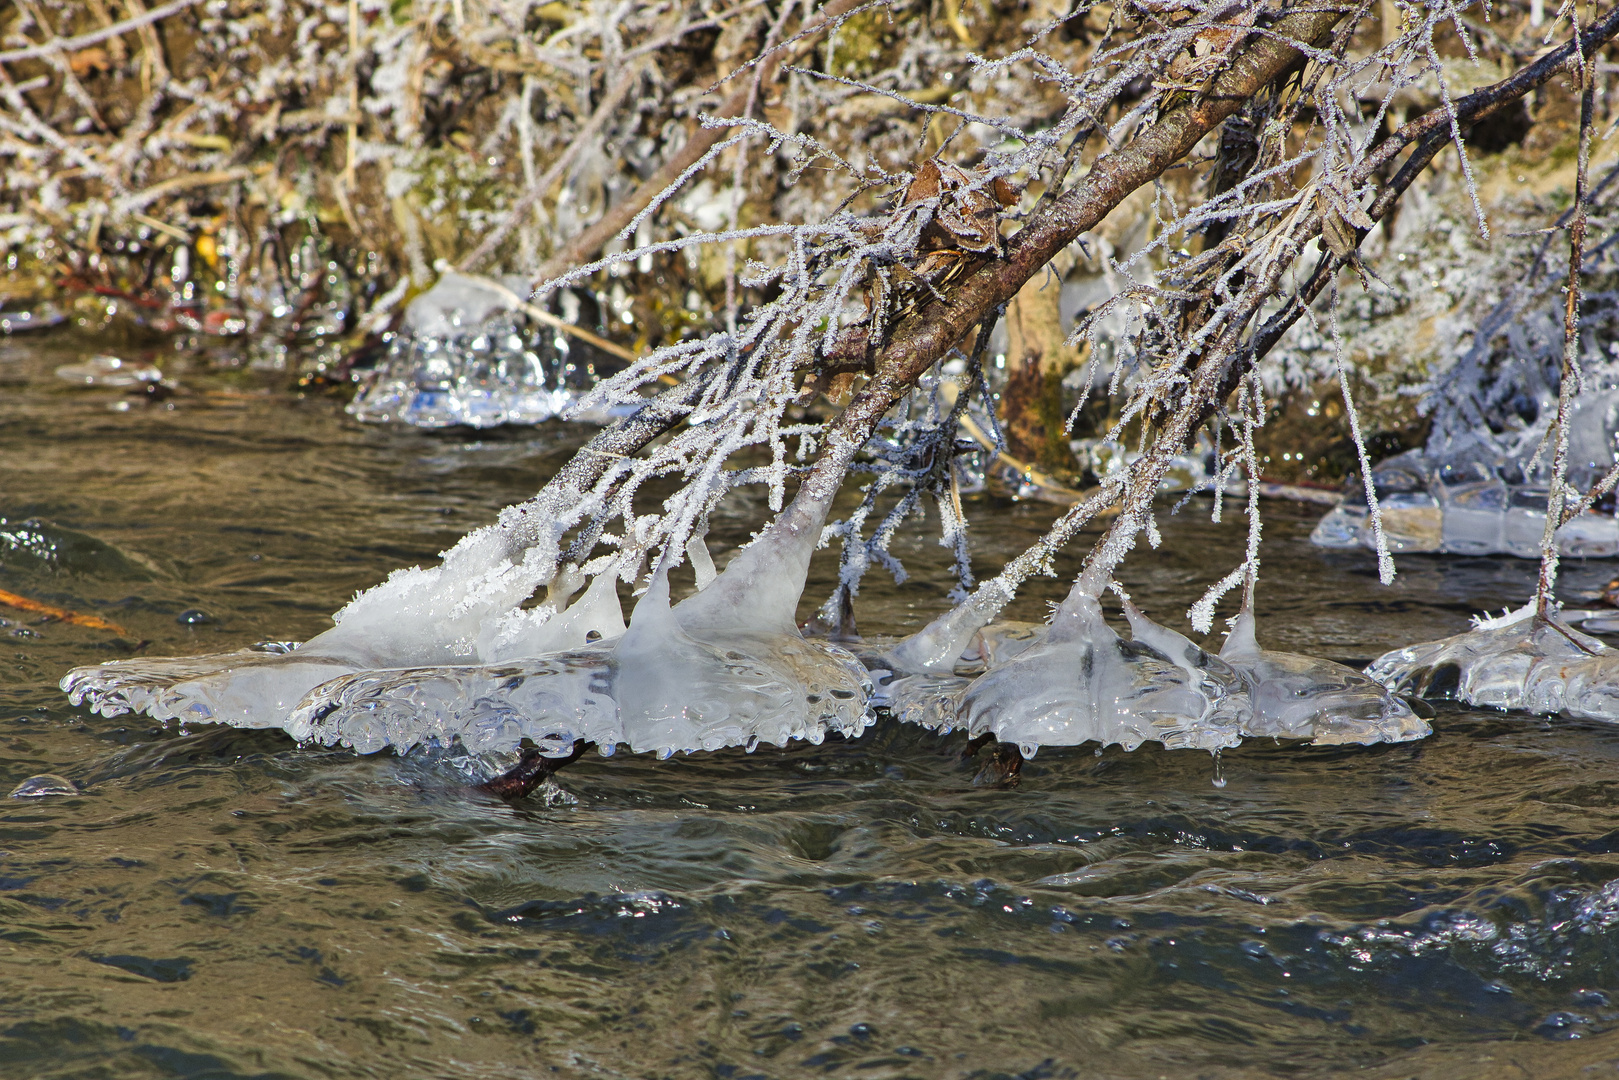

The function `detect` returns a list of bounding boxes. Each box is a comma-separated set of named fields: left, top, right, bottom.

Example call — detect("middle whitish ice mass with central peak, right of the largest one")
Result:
left=890, top=573, right=1248, bottom=758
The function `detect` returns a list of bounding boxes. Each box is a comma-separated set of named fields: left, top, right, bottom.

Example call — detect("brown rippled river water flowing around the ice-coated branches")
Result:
left=0, top=340, right=1619, bottom=1078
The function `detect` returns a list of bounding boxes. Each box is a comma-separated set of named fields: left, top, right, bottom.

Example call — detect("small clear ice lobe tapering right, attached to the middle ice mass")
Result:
left=1219, top=609, right=1433, bottom=746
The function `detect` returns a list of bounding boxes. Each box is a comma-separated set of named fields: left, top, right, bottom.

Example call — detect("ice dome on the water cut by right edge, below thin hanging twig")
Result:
left=1366, top=602, right=1619, bottom=721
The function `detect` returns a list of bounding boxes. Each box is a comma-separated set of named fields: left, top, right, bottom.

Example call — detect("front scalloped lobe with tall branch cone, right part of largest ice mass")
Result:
left=288, top=476, right=871, bottom=756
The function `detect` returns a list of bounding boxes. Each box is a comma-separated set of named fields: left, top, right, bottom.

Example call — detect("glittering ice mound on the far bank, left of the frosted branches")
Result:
left=348, top=274, right=609, bottom=427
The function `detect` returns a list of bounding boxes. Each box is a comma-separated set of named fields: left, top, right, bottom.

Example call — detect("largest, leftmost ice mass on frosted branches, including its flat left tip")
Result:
left=63, top=469, right=871, bottom=756
